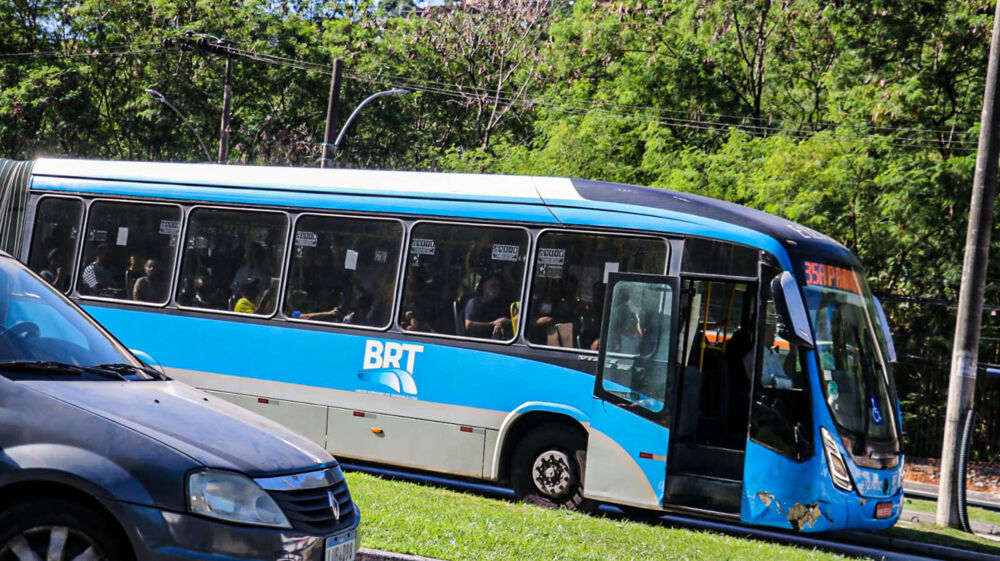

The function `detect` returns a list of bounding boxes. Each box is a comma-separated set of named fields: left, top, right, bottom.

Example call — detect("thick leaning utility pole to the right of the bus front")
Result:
left=937, top=2, right=1000, bottom=528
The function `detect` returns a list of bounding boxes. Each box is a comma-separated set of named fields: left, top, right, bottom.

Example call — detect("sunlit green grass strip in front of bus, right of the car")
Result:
left=347, top=473, right=845, bottom=561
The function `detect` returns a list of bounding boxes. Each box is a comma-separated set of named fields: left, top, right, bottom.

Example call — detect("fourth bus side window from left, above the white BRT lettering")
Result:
left=283, top=216, right=403, bottom=328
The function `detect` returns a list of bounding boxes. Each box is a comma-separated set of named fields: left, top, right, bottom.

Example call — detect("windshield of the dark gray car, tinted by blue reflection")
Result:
left=0, top=257, right=141, bottom=379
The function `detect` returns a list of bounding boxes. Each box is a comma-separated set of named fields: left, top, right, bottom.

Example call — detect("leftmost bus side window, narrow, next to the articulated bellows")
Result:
left=28, top=197, right=83, bottom=292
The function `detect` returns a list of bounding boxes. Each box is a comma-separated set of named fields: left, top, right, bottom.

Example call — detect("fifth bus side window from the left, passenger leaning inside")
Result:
left=399, top=222, right=528, bottom=341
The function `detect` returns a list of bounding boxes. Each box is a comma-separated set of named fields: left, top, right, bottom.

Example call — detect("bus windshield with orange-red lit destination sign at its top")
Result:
left=804, top=261, right=898, bottom=443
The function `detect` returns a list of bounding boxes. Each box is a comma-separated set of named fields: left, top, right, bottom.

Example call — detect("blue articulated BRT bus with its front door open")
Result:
left=0, top=159, right=903, bottom=531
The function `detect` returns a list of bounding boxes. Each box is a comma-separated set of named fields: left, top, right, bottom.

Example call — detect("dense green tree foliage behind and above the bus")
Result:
left=0, top=0, right=1000, bottom=458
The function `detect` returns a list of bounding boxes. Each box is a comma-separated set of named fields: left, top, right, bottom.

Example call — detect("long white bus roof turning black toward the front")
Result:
left=32, top=158, right=860, bottom=267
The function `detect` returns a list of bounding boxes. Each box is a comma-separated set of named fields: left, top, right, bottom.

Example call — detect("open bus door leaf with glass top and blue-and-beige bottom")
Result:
left=584, top=273, right=680, bottom=508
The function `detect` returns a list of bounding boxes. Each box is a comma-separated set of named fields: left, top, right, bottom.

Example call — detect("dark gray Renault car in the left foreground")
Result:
left=0, top=254, right=360, bottom=561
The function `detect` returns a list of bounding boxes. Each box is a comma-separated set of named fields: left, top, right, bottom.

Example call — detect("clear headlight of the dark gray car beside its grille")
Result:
left=188, top=469, right=292, bottom=528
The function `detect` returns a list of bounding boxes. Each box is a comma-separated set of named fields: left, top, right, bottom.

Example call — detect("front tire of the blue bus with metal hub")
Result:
left=510, top=425, right=597, bottom=512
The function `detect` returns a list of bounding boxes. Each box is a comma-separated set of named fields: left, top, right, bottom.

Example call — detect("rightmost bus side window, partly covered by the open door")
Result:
left=525, top=232, right=667, bottom=350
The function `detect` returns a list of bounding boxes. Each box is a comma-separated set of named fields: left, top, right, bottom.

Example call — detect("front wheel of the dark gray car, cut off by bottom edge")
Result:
left=0, top=499, right=134, bottom=561
